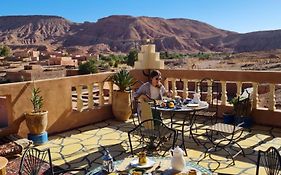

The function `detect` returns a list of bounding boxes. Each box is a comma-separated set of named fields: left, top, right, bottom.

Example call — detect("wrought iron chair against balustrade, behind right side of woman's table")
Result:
left=196, top=78, right=220, bottom=124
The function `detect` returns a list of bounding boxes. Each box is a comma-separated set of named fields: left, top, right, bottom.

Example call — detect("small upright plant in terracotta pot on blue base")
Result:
left=25, top=88, right=48, bottom=135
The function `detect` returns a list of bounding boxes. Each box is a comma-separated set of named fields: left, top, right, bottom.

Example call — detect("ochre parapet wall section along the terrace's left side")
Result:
left=0, top=73, right=113, bottom=137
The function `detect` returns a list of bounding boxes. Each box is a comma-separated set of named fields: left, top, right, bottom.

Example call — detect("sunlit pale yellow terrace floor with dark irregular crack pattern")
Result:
left=34, top=116, right=281, bottom=175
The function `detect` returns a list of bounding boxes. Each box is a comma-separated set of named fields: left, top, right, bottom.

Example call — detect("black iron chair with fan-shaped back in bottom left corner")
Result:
left=19, top=147, right=85, bottom=175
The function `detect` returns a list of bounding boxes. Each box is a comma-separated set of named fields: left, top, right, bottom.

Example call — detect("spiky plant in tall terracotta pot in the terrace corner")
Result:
left=111, top=69, right=134, bottom=121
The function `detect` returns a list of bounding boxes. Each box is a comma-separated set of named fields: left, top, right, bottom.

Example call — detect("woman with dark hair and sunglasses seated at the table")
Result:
left=133, top=70, right=171, bottom=120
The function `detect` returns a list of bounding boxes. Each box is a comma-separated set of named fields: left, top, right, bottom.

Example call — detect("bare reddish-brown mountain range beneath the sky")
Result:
left=0, top=15, right=281, bottom=52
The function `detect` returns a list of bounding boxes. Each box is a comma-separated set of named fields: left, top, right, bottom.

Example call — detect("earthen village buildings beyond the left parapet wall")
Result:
left=0, top=49, right=129, bottom=83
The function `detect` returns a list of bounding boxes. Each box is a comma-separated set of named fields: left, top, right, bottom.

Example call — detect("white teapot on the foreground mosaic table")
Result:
left=171, top=146, right=185, bottom=171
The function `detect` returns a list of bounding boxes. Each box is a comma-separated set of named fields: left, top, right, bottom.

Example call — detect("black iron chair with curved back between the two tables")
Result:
left=128, top=119, right=177, bottom=156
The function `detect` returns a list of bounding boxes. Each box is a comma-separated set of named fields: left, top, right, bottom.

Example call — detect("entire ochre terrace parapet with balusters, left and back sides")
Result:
left=0, top=69, right=281, bottom=136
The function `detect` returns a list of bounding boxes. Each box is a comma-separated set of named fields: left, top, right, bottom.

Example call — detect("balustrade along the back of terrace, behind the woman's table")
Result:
left=131, top=69, right=281, bottom=126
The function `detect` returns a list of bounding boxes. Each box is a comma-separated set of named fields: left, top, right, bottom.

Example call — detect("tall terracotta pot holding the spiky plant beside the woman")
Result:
left=112, top=91, right=132, bottom=121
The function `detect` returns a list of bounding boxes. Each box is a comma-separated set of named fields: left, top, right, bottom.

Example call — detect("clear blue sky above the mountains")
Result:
left=0, top=0, right=281, bottom=33
